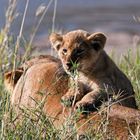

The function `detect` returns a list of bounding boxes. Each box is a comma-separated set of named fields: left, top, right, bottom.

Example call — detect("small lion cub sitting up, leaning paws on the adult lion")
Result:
left=50, top=30, right=137, bottom=110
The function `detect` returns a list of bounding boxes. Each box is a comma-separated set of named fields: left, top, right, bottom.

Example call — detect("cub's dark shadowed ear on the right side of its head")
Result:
left=87, top=32, right=106, bottom=51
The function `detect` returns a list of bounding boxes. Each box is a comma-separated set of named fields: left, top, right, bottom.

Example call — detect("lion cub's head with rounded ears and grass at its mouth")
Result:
left=50, top=30, right=106, bottom=73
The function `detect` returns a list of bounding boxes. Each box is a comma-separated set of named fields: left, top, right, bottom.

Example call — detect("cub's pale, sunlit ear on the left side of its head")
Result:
left=49, top=33, right=63, bottom=51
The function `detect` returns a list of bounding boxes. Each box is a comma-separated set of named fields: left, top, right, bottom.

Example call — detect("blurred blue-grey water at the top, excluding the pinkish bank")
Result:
left=0, top=0, right=140, bottom=55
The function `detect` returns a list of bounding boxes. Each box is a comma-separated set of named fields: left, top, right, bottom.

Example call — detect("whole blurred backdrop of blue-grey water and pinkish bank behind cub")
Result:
left=0, top=0, right=140, bottom=56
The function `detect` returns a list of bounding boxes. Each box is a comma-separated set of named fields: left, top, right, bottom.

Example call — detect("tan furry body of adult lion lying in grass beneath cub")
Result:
left=3, top=56, right=140, bottom=140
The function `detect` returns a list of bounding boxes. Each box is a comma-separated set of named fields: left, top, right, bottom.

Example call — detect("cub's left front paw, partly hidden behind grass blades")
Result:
left=61, top=95, right=74, bottom=107
